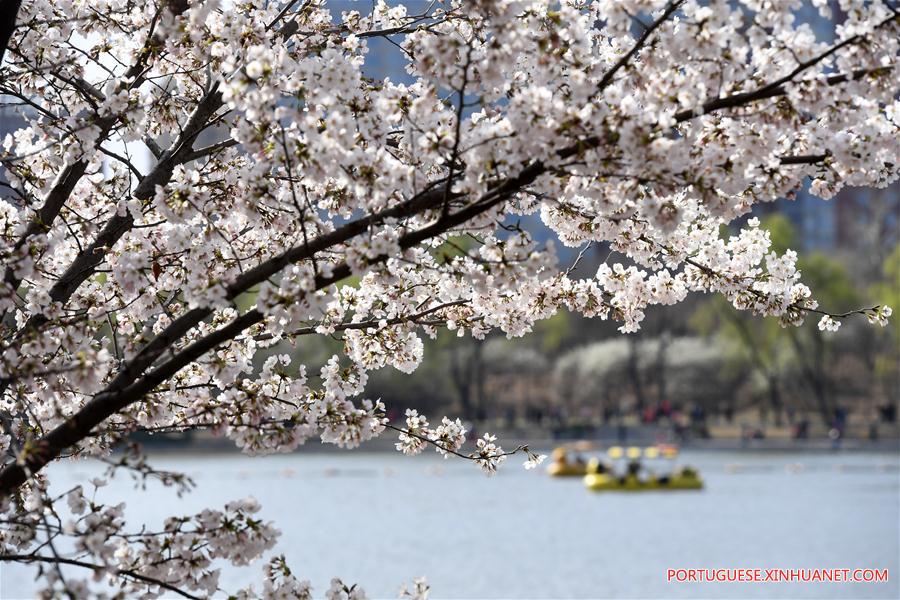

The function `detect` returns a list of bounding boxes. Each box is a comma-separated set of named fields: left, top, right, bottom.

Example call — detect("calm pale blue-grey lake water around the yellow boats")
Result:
left=0, top=451, right=900, bottom=599
